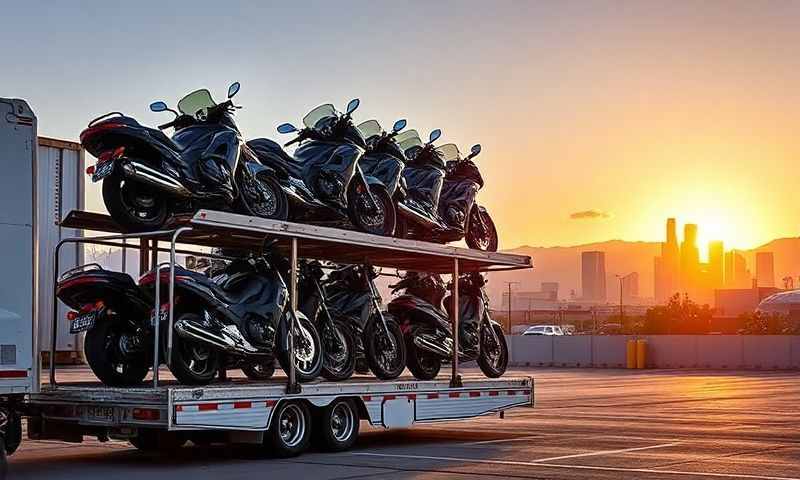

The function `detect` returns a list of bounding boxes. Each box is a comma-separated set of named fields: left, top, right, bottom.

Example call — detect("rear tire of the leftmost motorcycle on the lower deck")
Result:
left=83, top=321, right=149, bottom=387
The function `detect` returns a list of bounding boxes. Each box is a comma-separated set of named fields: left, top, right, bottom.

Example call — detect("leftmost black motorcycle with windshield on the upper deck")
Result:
left=80, top=82, right=288, bottom=232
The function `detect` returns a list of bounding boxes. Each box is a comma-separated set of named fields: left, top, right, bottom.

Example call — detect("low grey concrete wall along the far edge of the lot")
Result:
left=506, top=335, right=800, bottom=370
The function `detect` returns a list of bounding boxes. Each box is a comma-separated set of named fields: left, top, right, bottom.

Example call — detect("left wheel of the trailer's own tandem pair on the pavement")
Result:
left=264, top=401, right=311, bottom=458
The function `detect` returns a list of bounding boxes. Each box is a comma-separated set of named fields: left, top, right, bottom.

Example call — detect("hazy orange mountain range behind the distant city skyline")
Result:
left=487, top=238, right=800, bottom=304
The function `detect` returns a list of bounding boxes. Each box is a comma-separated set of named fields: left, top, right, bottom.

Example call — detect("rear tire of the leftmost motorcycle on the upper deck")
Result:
left=103, top=173, right=169, bottom=232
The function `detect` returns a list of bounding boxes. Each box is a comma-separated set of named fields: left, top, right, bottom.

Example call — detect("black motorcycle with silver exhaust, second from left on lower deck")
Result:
left=139, top=256, right=323, bottom=384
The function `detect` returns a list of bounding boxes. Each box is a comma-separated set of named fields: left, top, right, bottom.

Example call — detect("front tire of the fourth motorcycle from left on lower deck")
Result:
left=363, top=313, right=406, bottom=380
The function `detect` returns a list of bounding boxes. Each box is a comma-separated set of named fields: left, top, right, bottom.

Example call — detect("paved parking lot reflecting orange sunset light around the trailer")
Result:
left=9, top=369, right=800, bottom=480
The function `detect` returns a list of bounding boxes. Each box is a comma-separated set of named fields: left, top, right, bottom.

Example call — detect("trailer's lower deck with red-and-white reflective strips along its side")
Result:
left=29, top=377, right=533, bottom=433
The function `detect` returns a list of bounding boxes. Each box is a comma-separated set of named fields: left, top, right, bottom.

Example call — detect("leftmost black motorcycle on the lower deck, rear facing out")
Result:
left=56, top=263, right=153, bottom=387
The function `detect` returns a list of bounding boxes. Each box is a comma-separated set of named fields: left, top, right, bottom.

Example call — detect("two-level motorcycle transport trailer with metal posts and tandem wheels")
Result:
left=0, top=210, right=533, bottom=468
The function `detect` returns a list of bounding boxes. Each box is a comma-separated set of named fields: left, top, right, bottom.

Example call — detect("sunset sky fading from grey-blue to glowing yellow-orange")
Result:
left=0, top=1, right=800, bottom=248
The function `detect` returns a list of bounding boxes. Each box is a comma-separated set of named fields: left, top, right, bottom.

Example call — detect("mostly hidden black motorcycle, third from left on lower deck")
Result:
left=297, top=261, right=356, bottom=382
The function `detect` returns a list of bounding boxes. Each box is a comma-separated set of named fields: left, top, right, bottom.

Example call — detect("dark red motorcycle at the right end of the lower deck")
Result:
left=388, top=272, right=508, bottom=380
